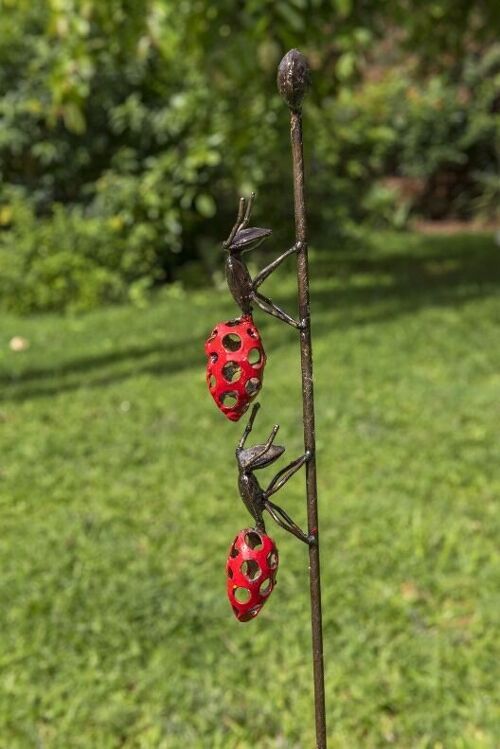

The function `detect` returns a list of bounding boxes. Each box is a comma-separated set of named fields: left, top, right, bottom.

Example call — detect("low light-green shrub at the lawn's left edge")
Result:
left=0, top=193, right=158, bottom=313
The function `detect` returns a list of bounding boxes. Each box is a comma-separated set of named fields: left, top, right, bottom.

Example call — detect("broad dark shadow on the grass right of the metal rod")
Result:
left=313, top=235, right=500, bottom=328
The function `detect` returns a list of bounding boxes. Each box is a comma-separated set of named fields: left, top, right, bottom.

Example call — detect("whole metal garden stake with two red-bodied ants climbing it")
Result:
left=205, top=49, right=326, bottom=749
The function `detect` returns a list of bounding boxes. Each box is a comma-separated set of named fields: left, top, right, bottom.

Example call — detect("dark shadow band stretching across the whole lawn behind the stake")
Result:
left=0, top=234, right=500, bottom=401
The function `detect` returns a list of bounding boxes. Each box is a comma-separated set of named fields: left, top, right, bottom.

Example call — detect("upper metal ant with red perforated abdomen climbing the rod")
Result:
left=205, top=193, right=304, bottom=421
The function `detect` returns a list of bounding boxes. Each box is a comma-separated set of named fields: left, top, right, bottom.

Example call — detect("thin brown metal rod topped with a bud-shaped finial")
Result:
left=278, top=49, right=327, bottom=749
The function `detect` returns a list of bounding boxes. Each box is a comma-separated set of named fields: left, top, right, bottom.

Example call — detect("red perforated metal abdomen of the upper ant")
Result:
left=205, top=315, right=266, bottom=421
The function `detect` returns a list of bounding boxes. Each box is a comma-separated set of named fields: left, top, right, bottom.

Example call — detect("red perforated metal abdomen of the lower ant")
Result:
left=226, top=528, right=279, bottom=622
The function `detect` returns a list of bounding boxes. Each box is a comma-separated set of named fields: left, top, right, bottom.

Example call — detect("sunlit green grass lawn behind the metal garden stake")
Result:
left=0, top=234, right=500, bottom=749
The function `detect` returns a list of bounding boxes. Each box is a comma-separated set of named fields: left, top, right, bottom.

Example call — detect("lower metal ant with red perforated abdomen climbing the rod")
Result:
left=226, top=403, right=316, bottom=622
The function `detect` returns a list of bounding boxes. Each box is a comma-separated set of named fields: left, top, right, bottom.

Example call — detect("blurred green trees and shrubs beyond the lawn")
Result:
left=0, top=0, right=500, bottom=313
